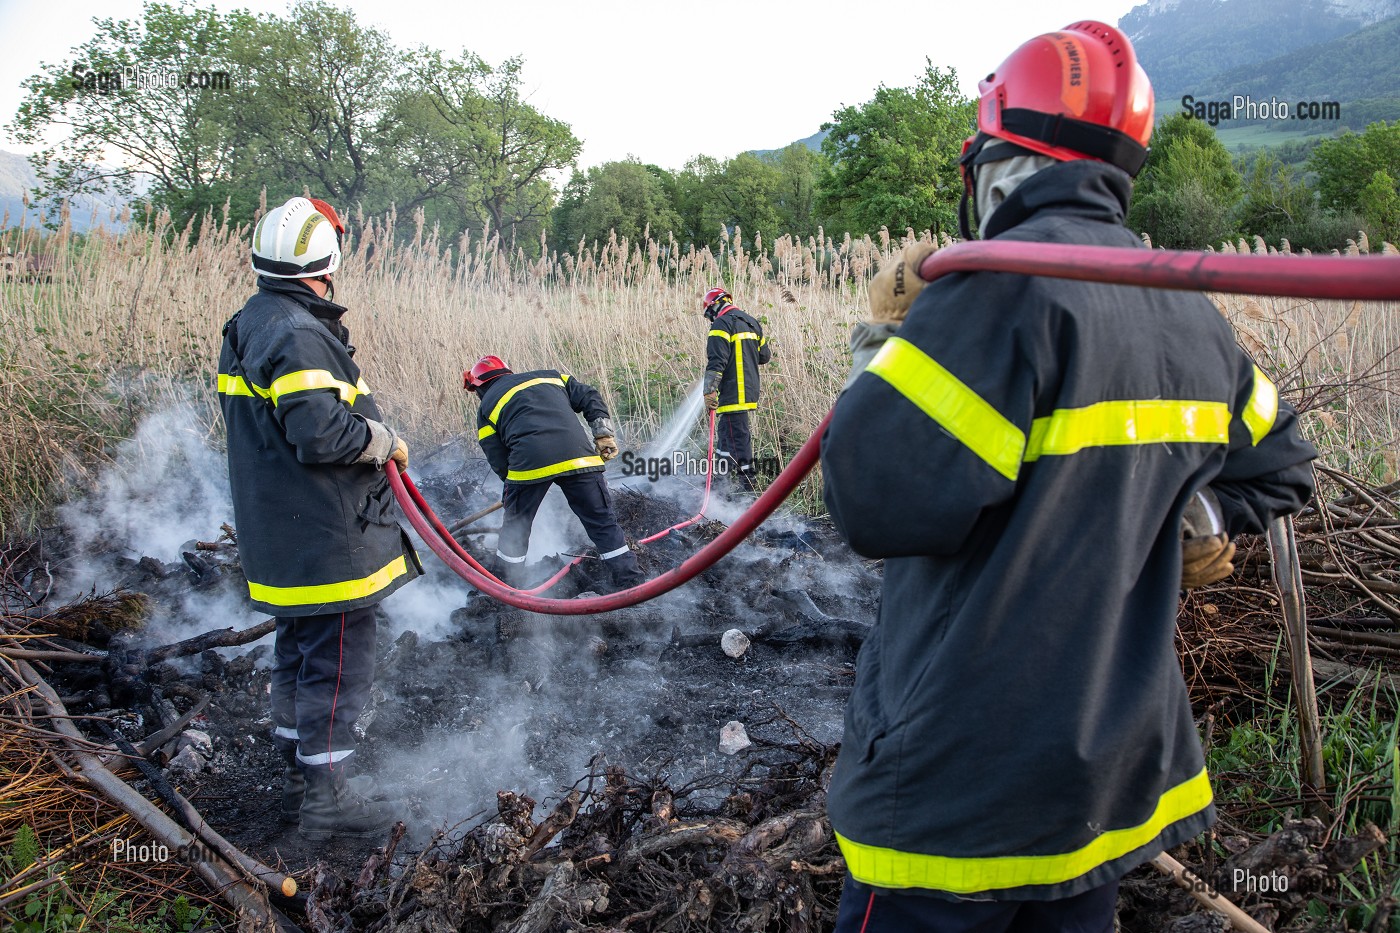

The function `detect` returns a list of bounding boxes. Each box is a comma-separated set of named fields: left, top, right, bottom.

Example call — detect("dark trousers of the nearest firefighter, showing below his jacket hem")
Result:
left=836, top=877, right=1119, bottom=933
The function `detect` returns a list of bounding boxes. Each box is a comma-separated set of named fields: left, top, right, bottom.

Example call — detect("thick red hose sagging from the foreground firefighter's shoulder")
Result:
left=385, top=241, right=1400, bottom=615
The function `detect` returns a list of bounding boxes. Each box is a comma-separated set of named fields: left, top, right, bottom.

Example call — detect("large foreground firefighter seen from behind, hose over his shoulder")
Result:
left=822, top=22, right=1316, bottom=933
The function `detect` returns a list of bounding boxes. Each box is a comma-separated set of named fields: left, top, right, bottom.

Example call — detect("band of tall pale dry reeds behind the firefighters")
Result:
left=0, top=205, right=1400, bottom=521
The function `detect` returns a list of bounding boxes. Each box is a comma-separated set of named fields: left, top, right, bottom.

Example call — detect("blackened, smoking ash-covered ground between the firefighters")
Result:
left=49, top=461, right=879, bottom=871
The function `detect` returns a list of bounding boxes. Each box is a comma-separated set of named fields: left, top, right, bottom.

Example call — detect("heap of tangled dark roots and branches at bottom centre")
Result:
left=308, top=714, right=846, bottom=933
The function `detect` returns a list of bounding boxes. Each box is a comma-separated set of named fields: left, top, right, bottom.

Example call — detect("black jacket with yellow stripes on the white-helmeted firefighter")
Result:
left=218, top=279, right=423, bottom=616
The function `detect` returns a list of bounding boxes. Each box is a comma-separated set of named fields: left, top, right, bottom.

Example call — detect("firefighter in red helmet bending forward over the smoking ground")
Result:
left=462, top=356, right=643, bottom=588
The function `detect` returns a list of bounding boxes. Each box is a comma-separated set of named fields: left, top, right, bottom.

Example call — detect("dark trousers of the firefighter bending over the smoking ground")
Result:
left=496, top=471, right=637, bottom=573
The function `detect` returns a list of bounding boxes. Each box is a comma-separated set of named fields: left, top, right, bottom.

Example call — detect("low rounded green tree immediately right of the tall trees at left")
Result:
left=552, top=160, right=680, bottom=249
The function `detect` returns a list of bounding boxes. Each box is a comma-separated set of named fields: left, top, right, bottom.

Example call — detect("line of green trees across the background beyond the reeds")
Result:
left=8, top=0, right=1400, bottom=254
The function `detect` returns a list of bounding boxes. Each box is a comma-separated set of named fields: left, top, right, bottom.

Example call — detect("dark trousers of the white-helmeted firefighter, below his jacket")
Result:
left=272, top=605, right=375, bottom=768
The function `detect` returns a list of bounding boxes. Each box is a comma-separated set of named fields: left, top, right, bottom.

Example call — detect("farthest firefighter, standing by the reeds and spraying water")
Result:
left=703, top=287, right=773, bottom=490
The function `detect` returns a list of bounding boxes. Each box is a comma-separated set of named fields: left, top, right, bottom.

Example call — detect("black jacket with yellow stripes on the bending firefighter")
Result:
left=476, top=370, right=612, bottom=483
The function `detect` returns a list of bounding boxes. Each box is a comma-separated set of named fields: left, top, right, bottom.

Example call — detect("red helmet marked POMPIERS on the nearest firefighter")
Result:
left=958, top=20, right=1154, bottom=240
